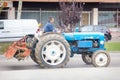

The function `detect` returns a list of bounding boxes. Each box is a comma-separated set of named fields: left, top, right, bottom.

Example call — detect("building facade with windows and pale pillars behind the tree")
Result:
left=0, top=0, right=120, bottom=28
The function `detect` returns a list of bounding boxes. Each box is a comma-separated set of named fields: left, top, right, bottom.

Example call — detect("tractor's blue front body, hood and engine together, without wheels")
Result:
left=63, top=32, right=104, bottom=57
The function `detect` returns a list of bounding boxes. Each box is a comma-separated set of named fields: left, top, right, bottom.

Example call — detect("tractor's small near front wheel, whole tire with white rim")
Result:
left=92, top=50, right=110, bottom=67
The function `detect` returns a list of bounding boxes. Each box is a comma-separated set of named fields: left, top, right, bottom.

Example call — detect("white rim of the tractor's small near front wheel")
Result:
left=95, top=53, right=108, bottom=66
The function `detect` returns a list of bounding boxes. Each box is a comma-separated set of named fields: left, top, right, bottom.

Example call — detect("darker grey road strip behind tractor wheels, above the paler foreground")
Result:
left=0, top=53, right=120, bottom=71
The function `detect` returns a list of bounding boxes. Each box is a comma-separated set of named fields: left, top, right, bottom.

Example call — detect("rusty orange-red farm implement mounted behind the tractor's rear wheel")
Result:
left=4, top=36, right=31, bottom=60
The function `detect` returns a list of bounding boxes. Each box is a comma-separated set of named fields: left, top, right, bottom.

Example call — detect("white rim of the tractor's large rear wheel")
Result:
left=42, top=40, right=66, bottom=65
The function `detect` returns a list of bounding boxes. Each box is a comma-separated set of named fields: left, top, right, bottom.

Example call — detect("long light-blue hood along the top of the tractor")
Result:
left=63, top=32, right=105, bottom=41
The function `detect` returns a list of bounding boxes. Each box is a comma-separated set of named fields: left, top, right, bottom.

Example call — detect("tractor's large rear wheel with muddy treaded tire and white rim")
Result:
left=35, top=33, right=71, bottom=68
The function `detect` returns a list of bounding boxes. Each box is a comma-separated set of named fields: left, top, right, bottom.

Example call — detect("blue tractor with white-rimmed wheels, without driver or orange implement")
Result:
left=30, top=32, right=110, bottom=68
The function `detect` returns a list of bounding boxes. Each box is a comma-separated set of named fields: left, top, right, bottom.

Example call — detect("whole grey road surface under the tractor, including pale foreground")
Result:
left=0, top=53, right=120, bottom=80
